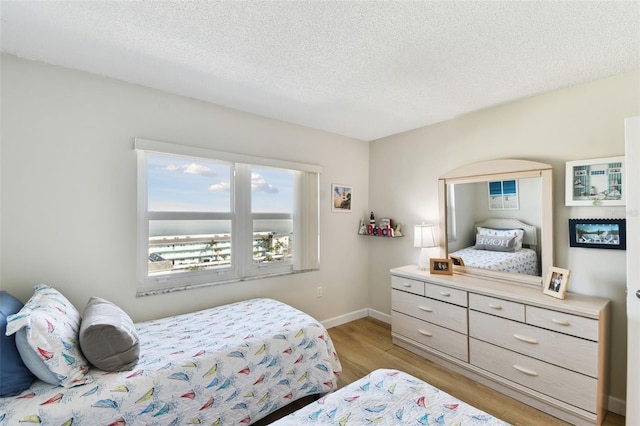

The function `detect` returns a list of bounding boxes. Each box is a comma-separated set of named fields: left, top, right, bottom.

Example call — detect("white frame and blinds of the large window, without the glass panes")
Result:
left=135, top=138, right=322, bottom=296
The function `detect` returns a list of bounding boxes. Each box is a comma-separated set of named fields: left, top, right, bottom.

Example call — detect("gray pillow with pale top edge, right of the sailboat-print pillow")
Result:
left=80, top=297, right=140, bottom=371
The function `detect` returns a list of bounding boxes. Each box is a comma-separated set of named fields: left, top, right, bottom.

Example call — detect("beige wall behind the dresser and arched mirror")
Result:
left=369, top=72, right=640, bottom=406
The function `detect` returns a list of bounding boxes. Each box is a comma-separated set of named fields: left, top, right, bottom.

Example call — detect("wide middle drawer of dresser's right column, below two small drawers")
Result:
left=469, top=311, right=598, bottom=377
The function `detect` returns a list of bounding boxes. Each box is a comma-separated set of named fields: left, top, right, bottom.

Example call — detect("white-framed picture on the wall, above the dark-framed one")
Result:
left=565, top=156, right=625, bottom=206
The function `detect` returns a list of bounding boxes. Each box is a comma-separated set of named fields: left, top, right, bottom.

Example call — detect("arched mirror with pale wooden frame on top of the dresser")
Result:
left=438, top=160, right=553, bottom=285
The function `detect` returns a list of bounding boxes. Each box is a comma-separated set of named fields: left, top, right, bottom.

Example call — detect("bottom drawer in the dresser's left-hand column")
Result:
left=391, top=311, right=469, bottom=362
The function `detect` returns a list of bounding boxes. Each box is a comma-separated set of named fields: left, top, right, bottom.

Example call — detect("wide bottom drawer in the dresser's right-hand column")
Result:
left=469, top=339, right=598, bottom=413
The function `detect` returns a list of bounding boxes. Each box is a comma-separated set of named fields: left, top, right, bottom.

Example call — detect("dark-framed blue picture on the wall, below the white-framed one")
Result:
left=569, top=219, right=627, bottom=250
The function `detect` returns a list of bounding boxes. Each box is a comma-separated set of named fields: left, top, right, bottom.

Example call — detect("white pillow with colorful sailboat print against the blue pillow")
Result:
left=7, top=284, right=89, bottom=387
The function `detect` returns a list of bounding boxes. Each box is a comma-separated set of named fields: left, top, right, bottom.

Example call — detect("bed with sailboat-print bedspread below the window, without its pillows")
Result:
left=0, top=299, right=341, bottom=426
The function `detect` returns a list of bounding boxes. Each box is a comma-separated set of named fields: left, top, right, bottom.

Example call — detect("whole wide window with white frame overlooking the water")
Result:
left=136, top=139, right=321, bottom=294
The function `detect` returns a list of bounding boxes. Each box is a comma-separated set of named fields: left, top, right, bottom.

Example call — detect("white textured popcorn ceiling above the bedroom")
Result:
left=0, top=0, right=640, bottom=140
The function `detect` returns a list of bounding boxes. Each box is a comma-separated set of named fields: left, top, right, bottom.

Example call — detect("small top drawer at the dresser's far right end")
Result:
left=526, top=306, right=598, bottom=342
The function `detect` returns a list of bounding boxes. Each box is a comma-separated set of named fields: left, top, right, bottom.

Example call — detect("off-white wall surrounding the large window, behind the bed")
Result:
left=0, top=55, right=369, bottom=320
